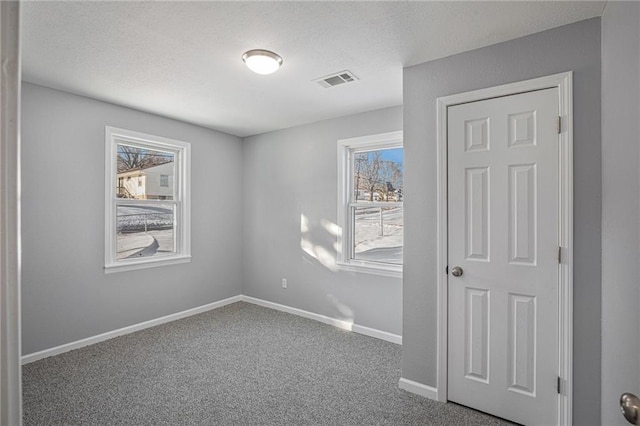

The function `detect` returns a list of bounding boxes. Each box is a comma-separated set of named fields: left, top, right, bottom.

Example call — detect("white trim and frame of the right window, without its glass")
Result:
left=336, top=131, right=404, bottom=278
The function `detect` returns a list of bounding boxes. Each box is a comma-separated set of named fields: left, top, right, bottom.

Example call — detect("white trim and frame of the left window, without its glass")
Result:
left=104, top=126, right=191, bottom=273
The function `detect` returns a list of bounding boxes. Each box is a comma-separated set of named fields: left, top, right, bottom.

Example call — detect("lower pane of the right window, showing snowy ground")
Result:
left=351, top=206, right=404, bottom=265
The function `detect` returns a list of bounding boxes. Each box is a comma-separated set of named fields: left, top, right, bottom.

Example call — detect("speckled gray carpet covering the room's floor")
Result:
left=23, top=303, right=509, bottom=425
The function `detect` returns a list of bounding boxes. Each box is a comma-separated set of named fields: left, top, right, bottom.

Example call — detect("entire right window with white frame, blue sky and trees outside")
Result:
left=338, top=132, right=404, bottom=276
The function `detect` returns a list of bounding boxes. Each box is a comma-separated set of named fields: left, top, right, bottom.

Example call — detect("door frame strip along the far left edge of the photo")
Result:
left=0, top=1, right=22, bottom=425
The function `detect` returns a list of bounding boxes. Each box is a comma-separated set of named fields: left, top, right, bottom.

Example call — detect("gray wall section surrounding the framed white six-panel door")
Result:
left=402, top=18, right=601, bottom=425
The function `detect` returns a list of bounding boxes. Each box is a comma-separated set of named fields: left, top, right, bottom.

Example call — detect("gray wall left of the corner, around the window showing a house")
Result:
left=22, top=84, right=242, bottom=354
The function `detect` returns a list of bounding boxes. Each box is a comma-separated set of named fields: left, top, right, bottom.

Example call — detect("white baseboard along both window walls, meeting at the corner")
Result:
left=21, top=295, right=402, bottom=365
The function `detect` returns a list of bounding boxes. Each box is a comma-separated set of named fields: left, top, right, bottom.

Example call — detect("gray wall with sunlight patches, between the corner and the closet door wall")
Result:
left=243, top=107, right=402, bottom=334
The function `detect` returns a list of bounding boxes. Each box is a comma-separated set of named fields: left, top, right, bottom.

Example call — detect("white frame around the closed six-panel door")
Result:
left=436, top=71, right=573, bottom=425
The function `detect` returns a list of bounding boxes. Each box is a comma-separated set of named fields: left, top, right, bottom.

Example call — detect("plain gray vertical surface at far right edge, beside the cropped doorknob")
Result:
left=602, top=2, right=640, bottom=425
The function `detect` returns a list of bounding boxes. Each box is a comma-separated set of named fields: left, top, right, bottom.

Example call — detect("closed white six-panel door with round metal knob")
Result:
left=447, top=88, right=559, bottom=425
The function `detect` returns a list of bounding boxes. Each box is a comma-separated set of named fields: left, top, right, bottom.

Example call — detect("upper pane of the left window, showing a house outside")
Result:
left=116, top=144, right=176, bottom=200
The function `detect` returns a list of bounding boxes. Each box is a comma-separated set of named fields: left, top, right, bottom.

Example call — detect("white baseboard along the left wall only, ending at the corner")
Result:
left=21, top=295, right=242, bottom=365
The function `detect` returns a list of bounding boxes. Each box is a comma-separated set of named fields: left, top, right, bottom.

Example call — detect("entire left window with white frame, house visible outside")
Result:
left=105, top=127, right=191, bottom=272
